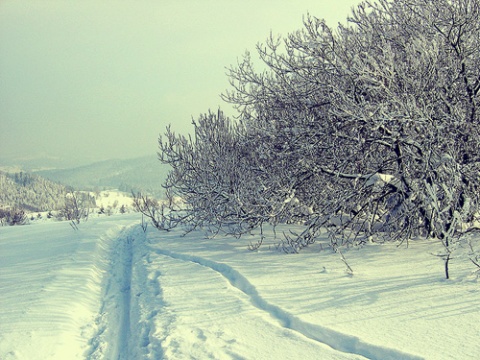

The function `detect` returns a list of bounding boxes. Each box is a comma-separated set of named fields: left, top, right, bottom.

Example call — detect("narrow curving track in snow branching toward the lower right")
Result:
left=153, top=249, right=423, bottom=360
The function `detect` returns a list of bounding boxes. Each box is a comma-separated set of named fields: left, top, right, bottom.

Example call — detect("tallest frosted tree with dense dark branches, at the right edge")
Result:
left=224, top=0, right=480, bottom=250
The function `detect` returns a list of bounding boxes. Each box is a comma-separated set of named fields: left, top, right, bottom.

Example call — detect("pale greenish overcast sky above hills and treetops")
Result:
left=0, top=0, right=359, bottom=165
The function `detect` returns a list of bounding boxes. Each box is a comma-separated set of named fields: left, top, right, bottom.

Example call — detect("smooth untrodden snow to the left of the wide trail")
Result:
left=0, top=217, right=139, bottom=360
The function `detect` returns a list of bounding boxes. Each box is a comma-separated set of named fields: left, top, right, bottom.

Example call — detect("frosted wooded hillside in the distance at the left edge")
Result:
left=0, top=171, right=67, bottom=211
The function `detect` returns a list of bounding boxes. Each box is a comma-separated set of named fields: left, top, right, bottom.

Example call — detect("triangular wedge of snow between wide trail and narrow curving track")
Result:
left=146, top=243, right=352, bottom=360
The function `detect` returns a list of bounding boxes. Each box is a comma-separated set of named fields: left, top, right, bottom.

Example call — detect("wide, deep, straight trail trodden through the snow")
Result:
left=87, top=224, right=168, bottom=360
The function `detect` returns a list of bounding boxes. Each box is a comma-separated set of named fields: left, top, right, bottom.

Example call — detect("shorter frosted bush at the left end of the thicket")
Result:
left=159, top=111, right=251, bottom=233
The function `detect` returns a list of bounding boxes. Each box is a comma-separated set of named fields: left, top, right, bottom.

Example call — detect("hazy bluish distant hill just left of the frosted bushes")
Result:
left=35, top=156, right=169, bottom=196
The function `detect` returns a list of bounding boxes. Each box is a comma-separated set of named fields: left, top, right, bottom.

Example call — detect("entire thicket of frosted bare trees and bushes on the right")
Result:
left=160, top=0, right=480, bottom=277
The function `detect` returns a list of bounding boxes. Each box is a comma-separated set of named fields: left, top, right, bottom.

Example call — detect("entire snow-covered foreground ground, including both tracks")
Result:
left=0, top=214, right=480, bottom=360
